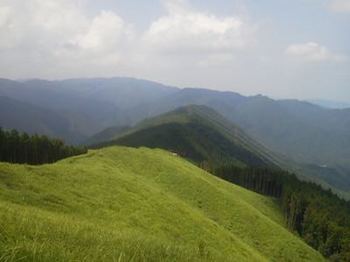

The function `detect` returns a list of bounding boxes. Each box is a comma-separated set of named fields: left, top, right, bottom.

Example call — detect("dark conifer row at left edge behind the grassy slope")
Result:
left=0, top=127, right=87, bottom=165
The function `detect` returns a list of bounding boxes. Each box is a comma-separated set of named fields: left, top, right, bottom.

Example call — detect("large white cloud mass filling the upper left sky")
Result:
left=0, top=0, right=132, bottom=77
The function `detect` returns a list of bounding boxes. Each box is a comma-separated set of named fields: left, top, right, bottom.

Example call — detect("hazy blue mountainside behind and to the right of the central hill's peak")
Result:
left=129, top=88, right=350, bottom=195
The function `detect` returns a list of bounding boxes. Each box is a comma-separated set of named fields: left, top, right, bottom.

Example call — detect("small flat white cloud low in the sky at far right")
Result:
left=286, top=42, right=345, bottom=62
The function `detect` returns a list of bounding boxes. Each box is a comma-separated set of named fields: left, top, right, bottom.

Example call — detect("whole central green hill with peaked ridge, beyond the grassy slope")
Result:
left=93, top=105, right=277, bottom=169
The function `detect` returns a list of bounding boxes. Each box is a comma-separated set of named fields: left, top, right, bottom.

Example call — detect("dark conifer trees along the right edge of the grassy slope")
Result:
left=214, top=165, right=350, bottom=261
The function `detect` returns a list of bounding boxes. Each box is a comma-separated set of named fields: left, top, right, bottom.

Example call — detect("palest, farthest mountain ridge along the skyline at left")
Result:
left=0, top=78, right=178, bottom=111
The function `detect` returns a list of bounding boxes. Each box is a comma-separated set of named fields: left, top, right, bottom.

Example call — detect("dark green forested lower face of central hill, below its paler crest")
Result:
left=98, top=122, right=272, bottom=169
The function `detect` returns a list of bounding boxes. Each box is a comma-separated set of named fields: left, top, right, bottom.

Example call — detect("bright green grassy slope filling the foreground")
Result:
left=0, top=147, right=323, bottom=261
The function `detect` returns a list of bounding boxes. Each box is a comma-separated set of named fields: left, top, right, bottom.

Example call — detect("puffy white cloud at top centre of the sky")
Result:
left=144, top=0, right=254, bottom=55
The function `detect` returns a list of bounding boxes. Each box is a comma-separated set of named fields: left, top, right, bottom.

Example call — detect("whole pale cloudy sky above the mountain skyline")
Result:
left=0, top=0, right=350, bottom=102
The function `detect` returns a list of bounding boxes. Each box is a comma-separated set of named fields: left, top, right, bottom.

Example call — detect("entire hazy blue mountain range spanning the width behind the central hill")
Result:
left=0, top=78, right=350, bottom=198
